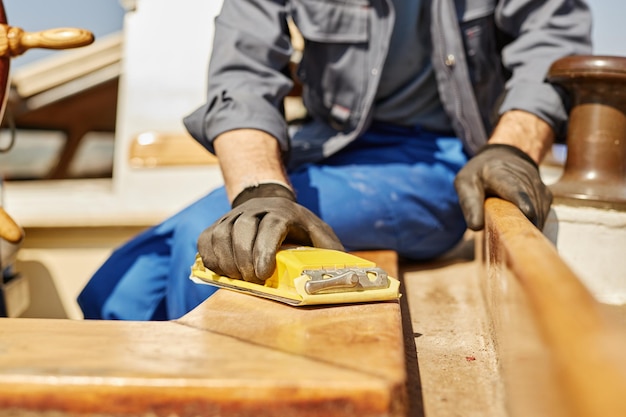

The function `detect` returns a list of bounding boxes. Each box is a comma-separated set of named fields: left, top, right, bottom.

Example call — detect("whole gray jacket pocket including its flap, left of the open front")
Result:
left=291, top=0, right=371, bottom=131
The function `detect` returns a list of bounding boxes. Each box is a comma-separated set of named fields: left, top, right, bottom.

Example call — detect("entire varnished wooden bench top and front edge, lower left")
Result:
left=0, top=282, right=406, bottom=416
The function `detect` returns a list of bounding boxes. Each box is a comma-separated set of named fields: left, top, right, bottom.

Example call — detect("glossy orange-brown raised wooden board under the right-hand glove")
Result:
left=483, top=199, right=626, bottom=417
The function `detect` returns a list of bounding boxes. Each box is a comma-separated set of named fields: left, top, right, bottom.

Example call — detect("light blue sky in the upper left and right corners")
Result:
left=4, top=0, right=626, bottom=66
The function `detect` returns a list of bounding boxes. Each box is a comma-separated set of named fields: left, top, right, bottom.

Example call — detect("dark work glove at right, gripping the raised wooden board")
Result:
left=454, top=144, right=552, bottom=230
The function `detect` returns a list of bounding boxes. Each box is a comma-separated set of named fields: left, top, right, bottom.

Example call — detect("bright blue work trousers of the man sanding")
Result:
left=78, top=126, right=467, bottom=320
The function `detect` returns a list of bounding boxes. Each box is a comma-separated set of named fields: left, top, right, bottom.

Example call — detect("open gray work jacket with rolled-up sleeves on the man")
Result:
left=184, top=0, right=591, bottom=163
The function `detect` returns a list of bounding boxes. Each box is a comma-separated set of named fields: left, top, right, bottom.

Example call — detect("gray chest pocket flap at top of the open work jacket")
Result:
left=291, top=0, right=369, bottom=43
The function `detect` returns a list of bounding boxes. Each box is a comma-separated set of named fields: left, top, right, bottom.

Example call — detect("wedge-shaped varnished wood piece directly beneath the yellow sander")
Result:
left=178, top=291, right=404, bottom=382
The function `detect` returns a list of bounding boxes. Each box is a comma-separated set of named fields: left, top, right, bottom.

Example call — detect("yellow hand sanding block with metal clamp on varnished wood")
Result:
left=190, top=246, right=400, bottom=306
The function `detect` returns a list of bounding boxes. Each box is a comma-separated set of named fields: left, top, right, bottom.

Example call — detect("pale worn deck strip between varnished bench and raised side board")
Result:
left=401, top=258, right=508, bottom=417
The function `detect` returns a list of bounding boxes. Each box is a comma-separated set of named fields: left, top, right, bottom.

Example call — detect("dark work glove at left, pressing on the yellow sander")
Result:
left=198, top=183, right=343, bottom=283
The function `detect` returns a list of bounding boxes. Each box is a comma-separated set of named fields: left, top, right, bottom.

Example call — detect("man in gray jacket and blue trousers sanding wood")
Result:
left=79, top=0, right=591, bottom=320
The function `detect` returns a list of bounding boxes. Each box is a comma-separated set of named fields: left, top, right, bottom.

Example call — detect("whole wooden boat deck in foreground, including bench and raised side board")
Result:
left=0, top=201, right=626, bottom=417
